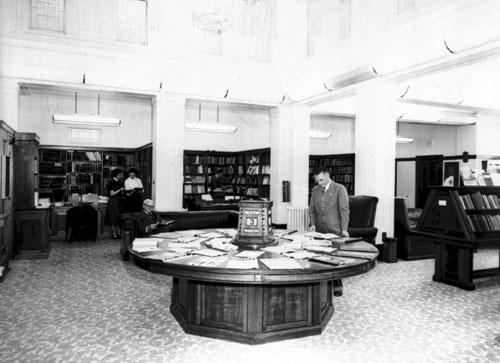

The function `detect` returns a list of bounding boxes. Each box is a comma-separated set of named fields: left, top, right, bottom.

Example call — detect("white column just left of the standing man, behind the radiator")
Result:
left=270, top=105, right=310, bottom=224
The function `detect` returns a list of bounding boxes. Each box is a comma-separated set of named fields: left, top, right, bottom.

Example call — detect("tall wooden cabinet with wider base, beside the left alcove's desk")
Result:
left=14, top=132, right=50, bottom=258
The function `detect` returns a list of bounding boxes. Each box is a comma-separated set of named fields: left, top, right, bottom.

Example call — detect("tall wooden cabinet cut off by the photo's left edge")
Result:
left=0, top=120, right=14, bottom=282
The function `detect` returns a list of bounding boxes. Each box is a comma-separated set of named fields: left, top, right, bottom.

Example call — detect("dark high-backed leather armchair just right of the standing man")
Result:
left=347, top=195, right=378, bottom=244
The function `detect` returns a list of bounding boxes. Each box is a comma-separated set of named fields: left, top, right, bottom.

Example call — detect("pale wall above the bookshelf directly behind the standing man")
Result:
left=309, top=115, right=355, bottom=155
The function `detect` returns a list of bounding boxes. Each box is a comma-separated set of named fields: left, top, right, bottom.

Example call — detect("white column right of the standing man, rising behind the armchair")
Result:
left=355, top=81, right=399, bottom=243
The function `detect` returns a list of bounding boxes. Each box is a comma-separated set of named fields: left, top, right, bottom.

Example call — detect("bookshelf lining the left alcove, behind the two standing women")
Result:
left=38, top=144, right=152, bottom=202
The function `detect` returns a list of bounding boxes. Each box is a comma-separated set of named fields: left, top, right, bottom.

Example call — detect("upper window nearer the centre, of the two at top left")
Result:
left=116, top=0, right=147, bottom=44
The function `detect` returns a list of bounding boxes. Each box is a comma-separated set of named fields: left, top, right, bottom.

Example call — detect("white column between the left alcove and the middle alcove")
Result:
left=152, top=93, right=186, bottom=211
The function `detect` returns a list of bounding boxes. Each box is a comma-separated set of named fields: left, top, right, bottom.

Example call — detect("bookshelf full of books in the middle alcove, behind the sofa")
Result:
left=183, top=148, right=271, bottom=207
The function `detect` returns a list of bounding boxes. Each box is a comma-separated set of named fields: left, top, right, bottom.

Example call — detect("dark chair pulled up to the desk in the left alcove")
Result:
left=66, top=193, right=97, bottom=242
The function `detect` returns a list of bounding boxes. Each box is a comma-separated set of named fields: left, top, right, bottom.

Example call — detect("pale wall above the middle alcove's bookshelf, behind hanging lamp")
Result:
left=184, top=101, right=270, bottom=151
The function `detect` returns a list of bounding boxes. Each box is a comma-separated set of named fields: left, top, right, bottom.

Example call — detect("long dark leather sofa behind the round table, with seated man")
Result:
left=120, top=210, right=238, bottom=261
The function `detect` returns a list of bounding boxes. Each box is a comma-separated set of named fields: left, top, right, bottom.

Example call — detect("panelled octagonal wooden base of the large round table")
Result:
left=170, top=278, right=334, bottom=344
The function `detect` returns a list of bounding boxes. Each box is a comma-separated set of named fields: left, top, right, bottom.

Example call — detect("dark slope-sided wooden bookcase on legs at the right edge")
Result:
left=417, top=186, right=500, bottom=290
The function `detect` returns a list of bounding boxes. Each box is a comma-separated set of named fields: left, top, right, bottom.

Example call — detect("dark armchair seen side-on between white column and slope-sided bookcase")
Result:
left=394, top=197, right=434, bottom=260
